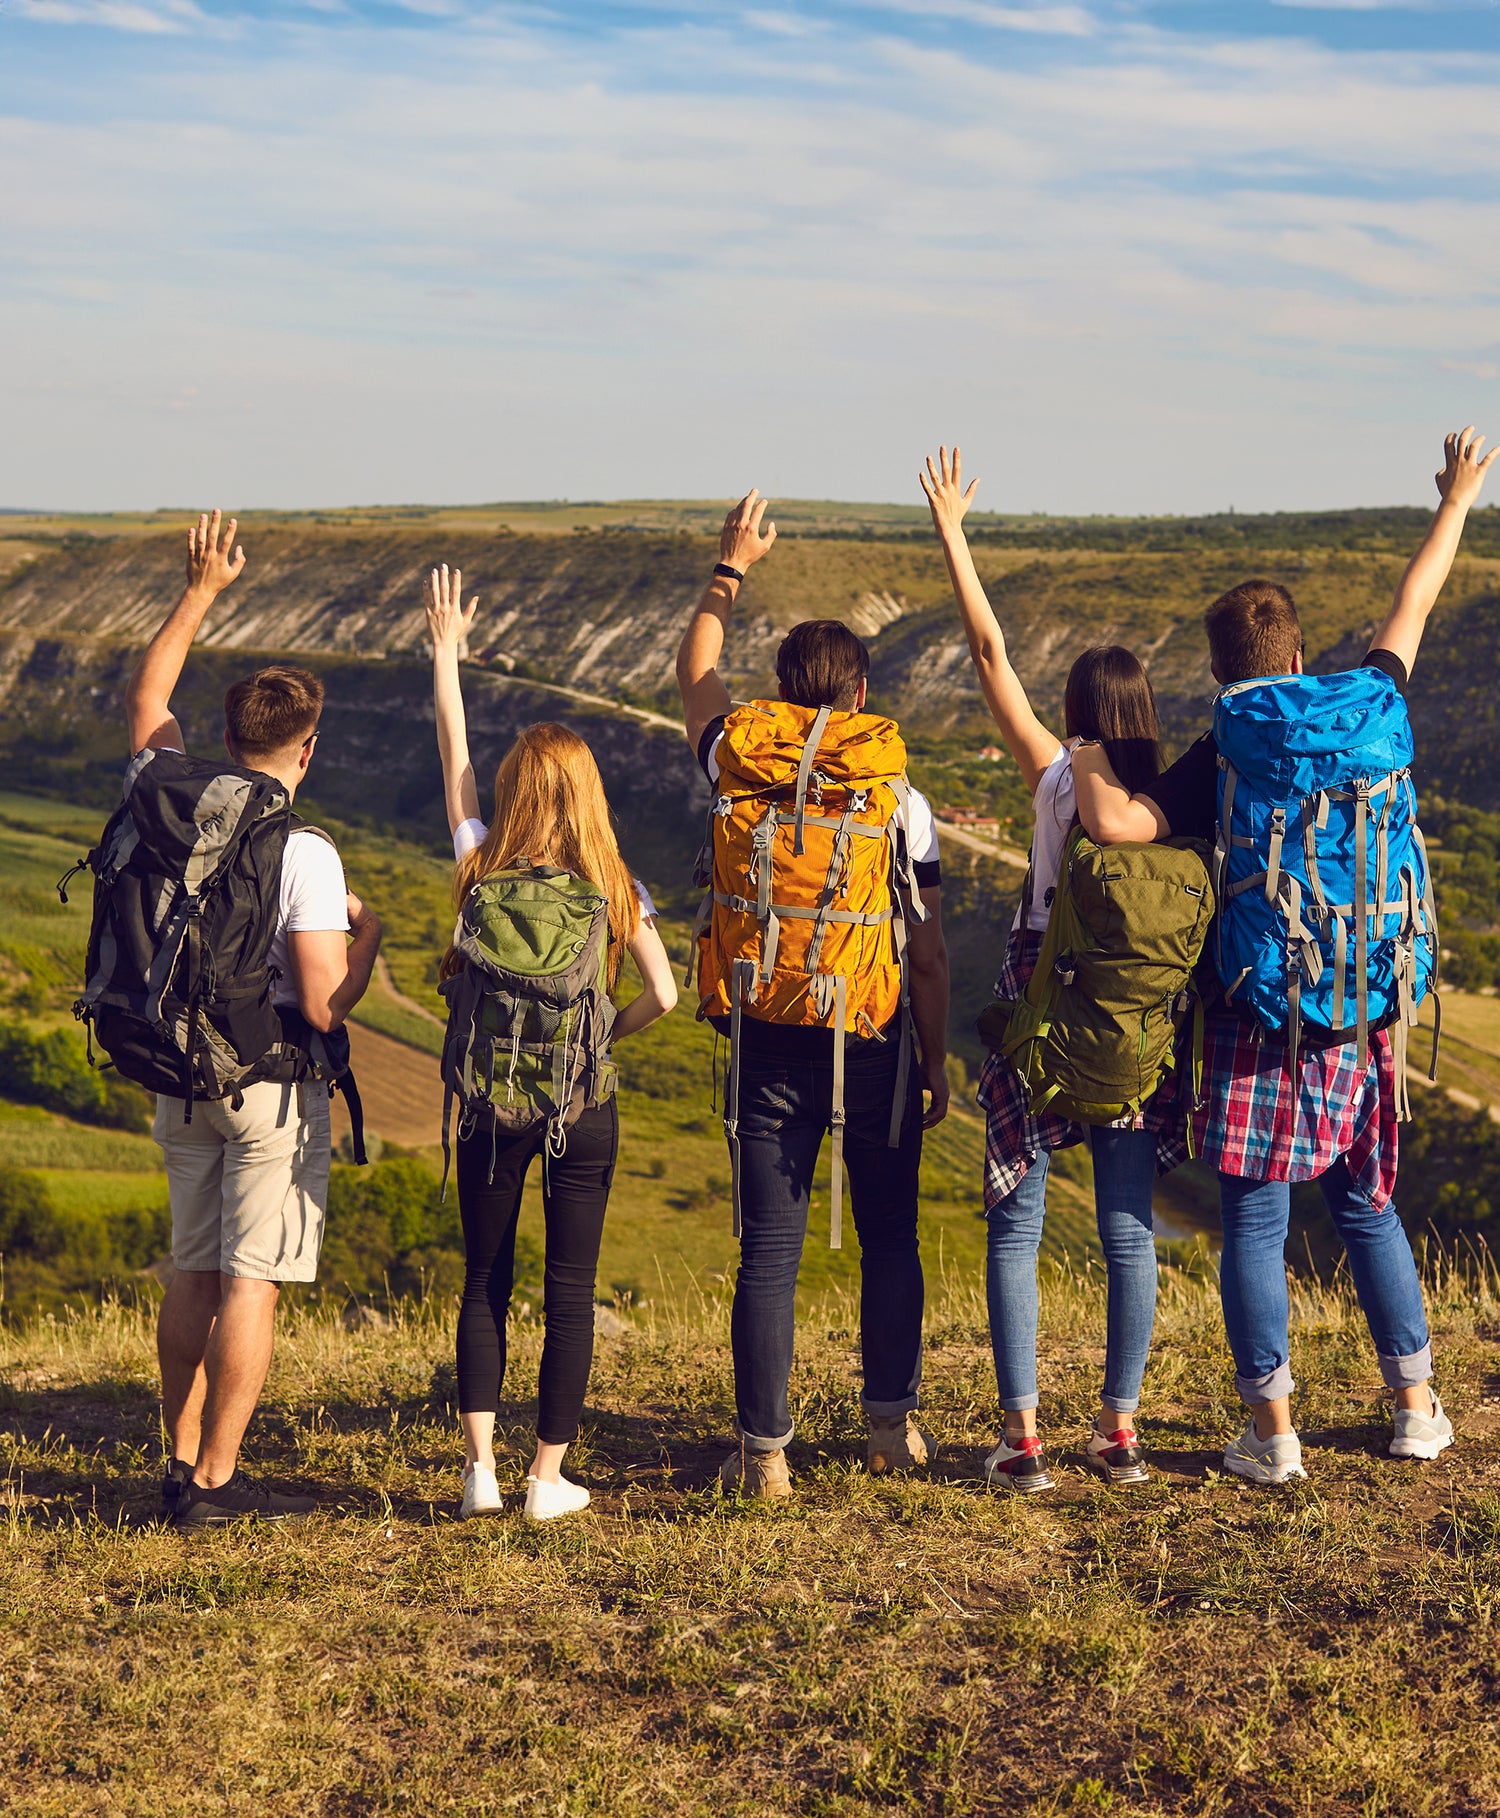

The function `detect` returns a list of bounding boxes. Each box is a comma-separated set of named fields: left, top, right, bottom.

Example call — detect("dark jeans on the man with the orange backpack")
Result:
left=731, top=1040, right=922, bottom=1451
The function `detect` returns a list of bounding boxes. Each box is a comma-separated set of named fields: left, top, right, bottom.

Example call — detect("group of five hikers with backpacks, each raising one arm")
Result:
left=78, top=429, right=1495, bottom=1527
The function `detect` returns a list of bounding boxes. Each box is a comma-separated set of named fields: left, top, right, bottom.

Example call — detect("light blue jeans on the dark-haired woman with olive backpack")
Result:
left=985, top=1127, right=1156, bottom=1414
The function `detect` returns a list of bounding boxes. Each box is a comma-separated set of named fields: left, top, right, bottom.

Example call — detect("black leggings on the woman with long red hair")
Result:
left=458, top=1098, right=620, bottom=1445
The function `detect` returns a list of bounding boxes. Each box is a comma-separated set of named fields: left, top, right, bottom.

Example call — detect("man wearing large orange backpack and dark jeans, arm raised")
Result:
left=676, top=491, right=947, bottom=1496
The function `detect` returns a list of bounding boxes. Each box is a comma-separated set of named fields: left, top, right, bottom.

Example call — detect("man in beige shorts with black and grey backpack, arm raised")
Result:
left=116, top=511, right=380, bottom=1527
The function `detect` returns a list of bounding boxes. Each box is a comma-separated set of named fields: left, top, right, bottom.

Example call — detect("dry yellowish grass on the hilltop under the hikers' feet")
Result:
left=0, top=1269, right=1500, bottom=1818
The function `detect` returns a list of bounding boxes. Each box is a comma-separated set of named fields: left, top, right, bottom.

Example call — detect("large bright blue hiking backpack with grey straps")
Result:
left=1213, top=667, right=1438, bottom=1116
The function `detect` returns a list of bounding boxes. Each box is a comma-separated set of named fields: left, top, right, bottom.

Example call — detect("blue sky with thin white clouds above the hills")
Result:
left=0, top=0, right=1500, bottom=511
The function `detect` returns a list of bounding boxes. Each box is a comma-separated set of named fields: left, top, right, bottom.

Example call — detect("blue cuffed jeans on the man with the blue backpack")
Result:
left=1218, top=1156, right=1433, bottom=1407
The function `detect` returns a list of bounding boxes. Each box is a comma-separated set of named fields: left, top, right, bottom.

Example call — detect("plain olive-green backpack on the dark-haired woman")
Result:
left=980, top=825, right=1213, bottom=1124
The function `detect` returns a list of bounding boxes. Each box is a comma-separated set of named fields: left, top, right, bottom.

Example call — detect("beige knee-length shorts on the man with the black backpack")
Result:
left=151, top=1080, right=329, bottom=1282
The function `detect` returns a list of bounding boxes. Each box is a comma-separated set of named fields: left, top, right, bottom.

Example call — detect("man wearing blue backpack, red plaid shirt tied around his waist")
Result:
left=1073, top=427, right=1495, bottom=1483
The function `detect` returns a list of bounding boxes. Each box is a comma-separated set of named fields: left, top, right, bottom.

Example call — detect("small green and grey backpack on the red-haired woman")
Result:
left=442, top=860, right=615, bottom=1182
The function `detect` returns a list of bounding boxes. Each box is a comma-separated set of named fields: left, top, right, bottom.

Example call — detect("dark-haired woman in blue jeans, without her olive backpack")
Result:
left=920, top=449, right=1182, bottom=1493
